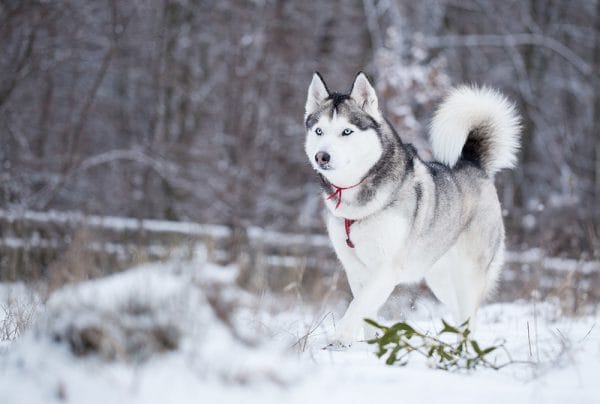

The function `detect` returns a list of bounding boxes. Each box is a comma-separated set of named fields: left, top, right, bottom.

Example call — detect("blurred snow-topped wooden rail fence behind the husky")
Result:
left=0, top=210, right=600, bottom=305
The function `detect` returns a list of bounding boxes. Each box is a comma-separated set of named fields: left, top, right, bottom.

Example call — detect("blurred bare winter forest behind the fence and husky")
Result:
left=0, top=0, right=600, bottom=258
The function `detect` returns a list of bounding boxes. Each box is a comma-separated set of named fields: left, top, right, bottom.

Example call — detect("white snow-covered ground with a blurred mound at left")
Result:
left=0, top=254, right=600, bottom=404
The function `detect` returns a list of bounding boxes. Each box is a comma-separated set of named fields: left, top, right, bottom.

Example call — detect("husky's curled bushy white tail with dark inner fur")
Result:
left=431, top=86, right=521, bottom=177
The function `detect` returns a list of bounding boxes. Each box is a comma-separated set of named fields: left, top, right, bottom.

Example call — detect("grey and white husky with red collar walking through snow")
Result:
left=304, top=72, right=520, bottom=346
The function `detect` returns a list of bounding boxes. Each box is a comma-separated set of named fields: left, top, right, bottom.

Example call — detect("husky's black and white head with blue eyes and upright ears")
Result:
left=304, top=73, right=383, bottom=187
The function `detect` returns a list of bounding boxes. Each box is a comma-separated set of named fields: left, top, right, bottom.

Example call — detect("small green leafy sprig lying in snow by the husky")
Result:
left=365, top=319, right=516, bottom=371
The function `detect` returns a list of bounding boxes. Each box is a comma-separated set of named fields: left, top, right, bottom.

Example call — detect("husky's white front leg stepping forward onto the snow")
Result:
left=334, top=267, right=396, bottom=345
